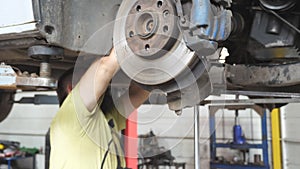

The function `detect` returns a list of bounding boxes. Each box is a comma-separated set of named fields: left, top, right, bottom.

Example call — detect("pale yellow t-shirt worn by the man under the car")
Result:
left=50, top=85, right=126, bottom=169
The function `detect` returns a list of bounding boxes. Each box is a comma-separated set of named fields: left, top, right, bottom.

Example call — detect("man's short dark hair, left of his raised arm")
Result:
left=56, top=68, right=74, bottom=106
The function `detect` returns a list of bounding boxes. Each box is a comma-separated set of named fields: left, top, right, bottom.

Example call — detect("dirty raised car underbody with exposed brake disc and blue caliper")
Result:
left=0, top=0, right=300, bottom=121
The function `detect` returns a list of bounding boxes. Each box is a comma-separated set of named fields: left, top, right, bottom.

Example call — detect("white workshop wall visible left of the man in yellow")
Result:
left=0, top=92, right=58, bottom=169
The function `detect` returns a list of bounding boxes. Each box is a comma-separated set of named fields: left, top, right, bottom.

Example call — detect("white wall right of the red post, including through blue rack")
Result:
left=138, top=95, right=272, bottom=169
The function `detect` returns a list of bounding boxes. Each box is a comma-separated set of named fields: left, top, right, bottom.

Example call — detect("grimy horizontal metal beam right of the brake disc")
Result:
left=209, top=63, right=300, bottom=98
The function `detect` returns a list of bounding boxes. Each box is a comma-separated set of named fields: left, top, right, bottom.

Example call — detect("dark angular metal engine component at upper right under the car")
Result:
left=248, top=11, right=300, bottom=61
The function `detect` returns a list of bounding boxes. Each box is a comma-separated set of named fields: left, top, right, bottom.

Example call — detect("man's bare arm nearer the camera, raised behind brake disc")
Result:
left=79, top=50, right=119, bottom=111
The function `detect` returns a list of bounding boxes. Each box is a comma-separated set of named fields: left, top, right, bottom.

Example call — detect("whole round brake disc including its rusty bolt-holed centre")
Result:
left=114, top=0, right=197, bottom=86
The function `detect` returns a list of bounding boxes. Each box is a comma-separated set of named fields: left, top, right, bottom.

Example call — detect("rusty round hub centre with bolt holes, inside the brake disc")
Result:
left=125, top=0, right=179, bottom=59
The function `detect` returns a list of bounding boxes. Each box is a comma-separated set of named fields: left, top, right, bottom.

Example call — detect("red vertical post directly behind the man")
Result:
left=124, top=110, right=138, bottom=169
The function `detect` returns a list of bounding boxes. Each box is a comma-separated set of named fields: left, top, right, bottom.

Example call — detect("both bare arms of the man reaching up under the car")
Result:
left=79, top=47, right=149, bottom=113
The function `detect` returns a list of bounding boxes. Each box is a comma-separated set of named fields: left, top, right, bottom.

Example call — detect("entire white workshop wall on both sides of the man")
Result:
left=0, top=92, right=274, bottom=169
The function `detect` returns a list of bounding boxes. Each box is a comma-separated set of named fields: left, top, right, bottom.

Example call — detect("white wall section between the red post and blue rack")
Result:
left=138, top=105, right=209, bottom=169
